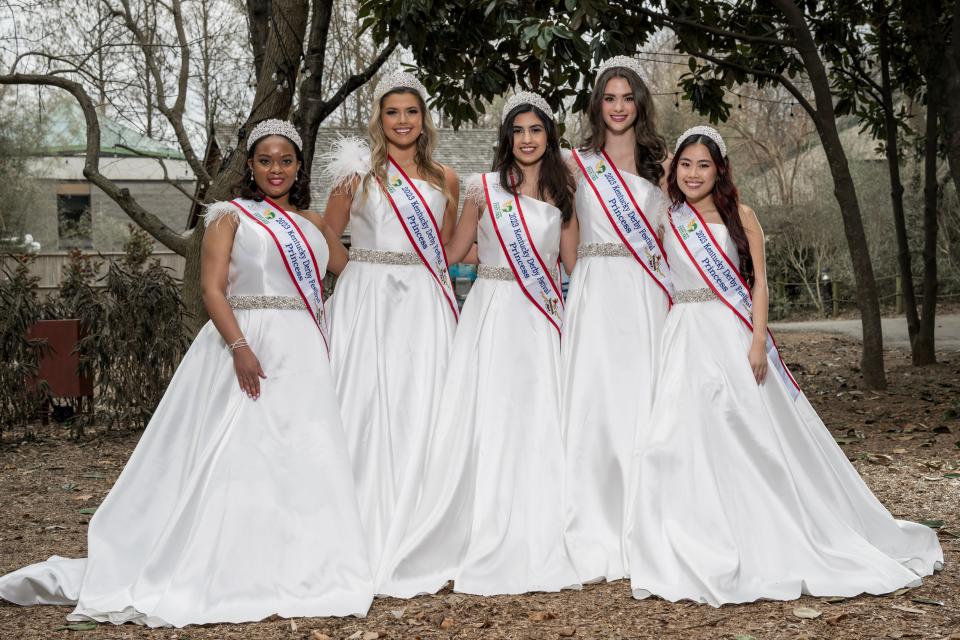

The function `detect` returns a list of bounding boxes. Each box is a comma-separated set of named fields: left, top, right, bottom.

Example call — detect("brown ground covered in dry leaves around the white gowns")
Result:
left=0, top=333, right=960, bottom=640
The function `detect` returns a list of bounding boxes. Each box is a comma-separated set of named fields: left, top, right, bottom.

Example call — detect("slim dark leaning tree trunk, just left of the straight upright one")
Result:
left=877, top=6, right=920, bottom=350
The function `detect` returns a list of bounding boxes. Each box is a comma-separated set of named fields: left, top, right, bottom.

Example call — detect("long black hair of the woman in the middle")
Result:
left=493, top=104, right=576, bottom=222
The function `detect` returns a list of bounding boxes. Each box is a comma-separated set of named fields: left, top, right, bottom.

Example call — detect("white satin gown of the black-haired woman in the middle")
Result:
left=375, top=182, right=577, bottom=598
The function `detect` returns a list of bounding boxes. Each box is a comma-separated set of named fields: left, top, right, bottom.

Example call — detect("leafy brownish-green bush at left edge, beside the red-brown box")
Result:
left=0, top=256, right=49, bottom=434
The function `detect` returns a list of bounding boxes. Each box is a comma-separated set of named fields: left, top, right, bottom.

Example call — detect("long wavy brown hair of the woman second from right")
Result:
left=581, top=67, right=667, bottom=184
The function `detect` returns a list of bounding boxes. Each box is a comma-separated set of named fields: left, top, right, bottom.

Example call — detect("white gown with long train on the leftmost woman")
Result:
left=0, top=204, right=373, bottom=627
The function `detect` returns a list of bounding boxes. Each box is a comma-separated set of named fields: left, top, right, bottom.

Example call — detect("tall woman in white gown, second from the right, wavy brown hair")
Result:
left=561, top=56, right=670, bottom=582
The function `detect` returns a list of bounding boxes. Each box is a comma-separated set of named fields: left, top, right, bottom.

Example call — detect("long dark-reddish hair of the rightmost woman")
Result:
left=667, top=135, right=754, bottom=289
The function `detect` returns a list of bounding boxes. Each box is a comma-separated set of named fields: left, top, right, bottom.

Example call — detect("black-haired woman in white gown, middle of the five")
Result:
left=375, top=92, right=577, bottom=597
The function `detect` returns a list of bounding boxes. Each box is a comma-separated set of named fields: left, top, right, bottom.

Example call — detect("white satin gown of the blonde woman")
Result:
left=327, top=179, right=457, bottom=571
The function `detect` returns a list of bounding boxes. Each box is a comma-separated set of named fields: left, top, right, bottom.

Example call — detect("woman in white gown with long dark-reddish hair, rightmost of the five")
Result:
left=628, top=127, right=943, bottom=606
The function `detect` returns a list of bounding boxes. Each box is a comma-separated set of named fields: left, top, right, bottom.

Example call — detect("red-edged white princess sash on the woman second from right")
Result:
left=573, top=149, right=674, bottom=304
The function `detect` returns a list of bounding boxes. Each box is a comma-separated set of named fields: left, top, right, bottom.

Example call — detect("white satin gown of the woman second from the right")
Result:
left=561, top=162, right=669, bottom=582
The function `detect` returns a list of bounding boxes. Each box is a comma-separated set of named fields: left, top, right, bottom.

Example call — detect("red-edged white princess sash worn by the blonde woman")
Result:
left=383, top=156, right=460, bottom=320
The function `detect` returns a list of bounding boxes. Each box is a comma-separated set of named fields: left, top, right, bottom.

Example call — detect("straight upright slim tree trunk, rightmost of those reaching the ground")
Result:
left=913, top=86, right=941, bottom=365
